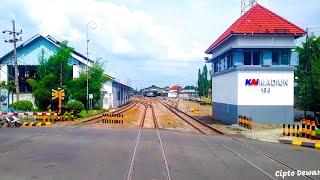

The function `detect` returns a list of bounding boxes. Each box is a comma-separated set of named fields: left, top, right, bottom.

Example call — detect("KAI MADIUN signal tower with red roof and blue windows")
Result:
left=205, top=4, right=305, bottom=124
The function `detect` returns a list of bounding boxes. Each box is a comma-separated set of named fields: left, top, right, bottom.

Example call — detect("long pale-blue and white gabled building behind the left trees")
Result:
left=0, top=34, right=132, bottom=108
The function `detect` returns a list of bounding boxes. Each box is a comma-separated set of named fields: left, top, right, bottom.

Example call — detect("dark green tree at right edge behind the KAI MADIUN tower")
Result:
left=295, top=35, right=320, bottom=112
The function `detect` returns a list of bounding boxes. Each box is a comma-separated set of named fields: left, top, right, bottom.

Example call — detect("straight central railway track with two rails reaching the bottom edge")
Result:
left=127, top=100, right=171, bottom=180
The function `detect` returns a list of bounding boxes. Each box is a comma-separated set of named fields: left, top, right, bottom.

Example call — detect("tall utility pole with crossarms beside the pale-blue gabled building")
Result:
left=3, top=20, right=22, bottom=101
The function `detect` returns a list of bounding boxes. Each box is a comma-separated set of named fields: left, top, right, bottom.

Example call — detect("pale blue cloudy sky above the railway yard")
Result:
left=0, top=0, right=320, bottom=89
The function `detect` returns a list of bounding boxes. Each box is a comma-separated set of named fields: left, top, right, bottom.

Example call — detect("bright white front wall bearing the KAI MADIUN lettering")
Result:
left=236, top=71, right=294, bottom=105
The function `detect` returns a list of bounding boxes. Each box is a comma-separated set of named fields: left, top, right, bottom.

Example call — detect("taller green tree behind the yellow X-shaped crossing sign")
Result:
left=27, top=41, right=73, bottom=110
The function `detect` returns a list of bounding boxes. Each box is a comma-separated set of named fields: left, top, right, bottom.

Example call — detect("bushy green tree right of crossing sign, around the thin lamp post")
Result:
left=69, top=60, right=110, bottom=109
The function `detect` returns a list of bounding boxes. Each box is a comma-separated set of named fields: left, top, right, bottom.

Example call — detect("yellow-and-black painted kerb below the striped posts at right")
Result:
left=279, top=136, right=320, bottom=149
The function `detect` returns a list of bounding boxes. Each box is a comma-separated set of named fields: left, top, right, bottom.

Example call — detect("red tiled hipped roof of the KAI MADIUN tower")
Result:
left=205, top=4, right=305, bottom=53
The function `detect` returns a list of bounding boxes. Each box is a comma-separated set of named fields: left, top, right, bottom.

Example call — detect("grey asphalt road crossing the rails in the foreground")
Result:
left=0, top=127, right=320, bottom=180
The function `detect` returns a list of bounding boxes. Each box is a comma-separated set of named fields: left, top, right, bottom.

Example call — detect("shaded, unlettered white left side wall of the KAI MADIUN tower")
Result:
left=212, top=71, right=238, bottom=105
